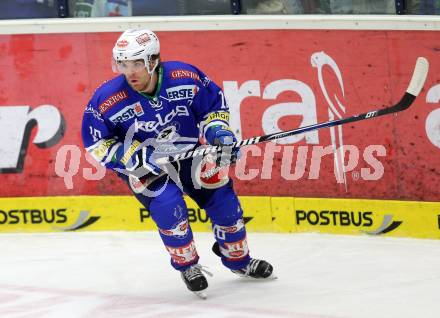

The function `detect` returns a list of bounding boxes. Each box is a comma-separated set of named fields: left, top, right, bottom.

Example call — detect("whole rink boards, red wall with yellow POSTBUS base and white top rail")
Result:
left=0, top=15, right=440, bottom=239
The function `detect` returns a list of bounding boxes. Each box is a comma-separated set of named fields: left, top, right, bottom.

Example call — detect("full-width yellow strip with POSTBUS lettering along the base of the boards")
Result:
left=0, top=196, right=440, bottom=239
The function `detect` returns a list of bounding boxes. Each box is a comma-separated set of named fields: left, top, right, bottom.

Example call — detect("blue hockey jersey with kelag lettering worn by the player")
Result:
left=82, top=61, right=228, bottom=169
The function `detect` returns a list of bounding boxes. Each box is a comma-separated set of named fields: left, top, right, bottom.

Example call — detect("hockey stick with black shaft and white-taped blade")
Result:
left=156, top=57, right=429, bottom=165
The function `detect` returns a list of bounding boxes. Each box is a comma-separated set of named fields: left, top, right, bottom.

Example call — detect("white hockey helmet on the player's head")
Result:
left=113, top=29, right=160, bottom=74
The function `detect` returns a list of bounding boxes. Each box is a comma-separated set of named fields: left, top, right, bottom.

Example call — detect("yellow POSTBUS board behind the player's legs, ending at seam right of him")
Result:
left=0, top=196, right=272, bottom=232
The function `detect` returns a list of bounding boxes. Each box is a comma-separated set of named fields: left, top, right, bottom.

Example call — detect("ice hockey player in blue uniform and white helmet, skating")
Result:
left=82, top=29, right=274, bottom=298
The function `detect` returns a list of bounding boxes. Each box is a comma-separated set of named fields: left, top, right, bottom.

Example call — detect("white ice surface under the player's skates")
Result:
left=0, top=232, right=440, bottom=318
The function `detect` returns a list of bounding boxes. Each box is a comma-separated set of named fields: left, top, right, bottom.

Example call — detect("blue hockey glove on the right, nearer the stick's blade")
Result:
left=205, top=125, right=240, bottom=163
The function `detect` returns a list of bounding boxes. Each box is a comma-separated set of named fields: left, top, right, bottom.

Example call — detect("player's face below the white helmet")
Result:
left=117, top=60, right=151, bottom=92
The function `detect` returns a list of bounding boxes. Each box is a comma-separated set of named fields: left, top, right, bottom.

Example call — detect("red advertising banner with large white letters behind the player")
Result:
left=0, top=30, right=440, bottom=201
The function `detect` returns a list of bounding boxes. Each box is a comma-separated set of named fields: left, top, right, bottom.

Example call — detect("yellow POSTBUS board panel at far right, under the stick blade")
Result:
left=294, top=198, right=440, bottom=239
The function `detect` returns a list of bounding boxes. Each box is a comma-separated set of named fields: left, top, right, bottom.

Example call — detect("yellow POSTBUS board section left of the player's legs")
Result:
left=0, top=196, right=154, bottom=232
